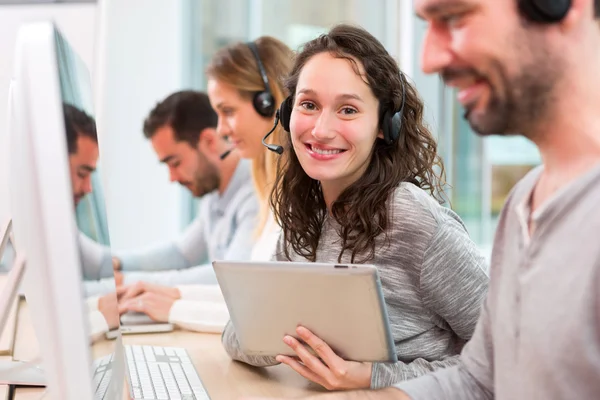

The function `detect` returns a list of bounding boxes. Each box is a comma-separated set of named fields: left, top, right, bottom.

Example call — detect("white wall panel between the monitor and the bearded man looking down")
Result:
left=95, top=0, right=189, bottom=250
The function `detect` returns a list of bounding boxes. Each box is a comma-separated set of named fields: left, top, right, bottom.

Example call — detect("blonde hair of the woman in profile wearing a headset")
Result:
left=206, top=36, right=294, bottom=235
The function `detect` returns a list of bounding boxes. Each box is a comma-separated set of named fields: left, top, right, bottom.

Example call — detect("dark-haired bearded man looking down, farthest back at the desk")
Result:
left=113, top=90, right=258, bottom=286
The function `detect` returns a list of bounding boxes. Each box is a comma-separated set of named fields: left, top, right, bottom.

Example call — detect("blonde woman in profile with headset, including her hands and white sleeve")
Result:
left=120, top=36, right=293, bottom=332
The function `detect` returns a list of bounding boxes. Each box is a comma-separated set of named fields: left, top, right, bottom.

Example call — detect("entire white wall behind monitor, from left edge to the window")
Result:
left=0, top=0, right=189, bottom=253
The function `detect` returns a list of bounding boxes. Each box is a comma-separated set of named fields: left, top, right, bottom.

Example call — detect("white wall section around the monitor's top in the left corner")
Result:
left=0, top=4, right=96, bottom=233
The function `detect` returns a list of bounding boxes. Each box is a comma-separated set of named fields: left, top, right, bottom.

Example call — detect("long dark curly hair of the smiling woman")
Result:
left=271, top=24, right=444, bottom=263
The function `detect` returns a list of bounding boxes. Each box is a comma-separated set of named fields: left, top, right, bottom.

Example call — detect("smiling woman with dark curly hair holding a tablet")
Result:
left=223, top=25, right=488, bottom=389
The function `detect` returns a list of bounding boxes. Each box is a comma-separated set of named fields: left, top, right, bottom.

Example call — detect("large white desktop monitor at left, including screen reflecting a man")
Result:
left=9, top=22, right=125, bottom=400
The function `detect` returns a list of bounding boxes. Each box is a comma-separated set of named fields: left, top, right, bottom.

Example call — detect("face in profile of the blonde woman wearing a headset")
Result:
left=207, top=78, right=273, bottom=159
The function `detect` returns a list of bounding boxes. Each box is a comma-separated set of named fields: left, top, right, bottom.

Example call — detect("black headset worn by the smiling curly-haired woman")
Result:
left=262, top=73, right=406, bottom=154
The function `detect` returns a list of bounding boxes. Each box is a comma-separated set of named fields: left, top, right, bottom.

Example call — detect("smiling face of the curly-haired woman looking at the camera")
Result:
left=290, top=52, right=382, bottom=198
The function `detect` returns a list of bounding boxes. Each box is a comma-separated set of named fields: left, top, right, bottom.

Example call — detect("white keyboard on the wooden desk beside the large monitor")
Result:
left=125, top=346, right=210, bottom=400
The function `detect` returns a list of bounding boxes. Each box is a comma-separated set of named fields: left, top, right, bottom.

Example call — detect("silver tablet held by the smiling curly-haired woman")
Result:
left=213, top=261, right=397, bottom=362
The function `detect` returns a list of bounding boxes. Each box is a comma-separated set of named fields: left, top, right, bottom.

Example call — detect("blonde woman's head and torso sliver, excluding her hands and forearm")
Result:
left=206, top=36, right=293, bottom=260
